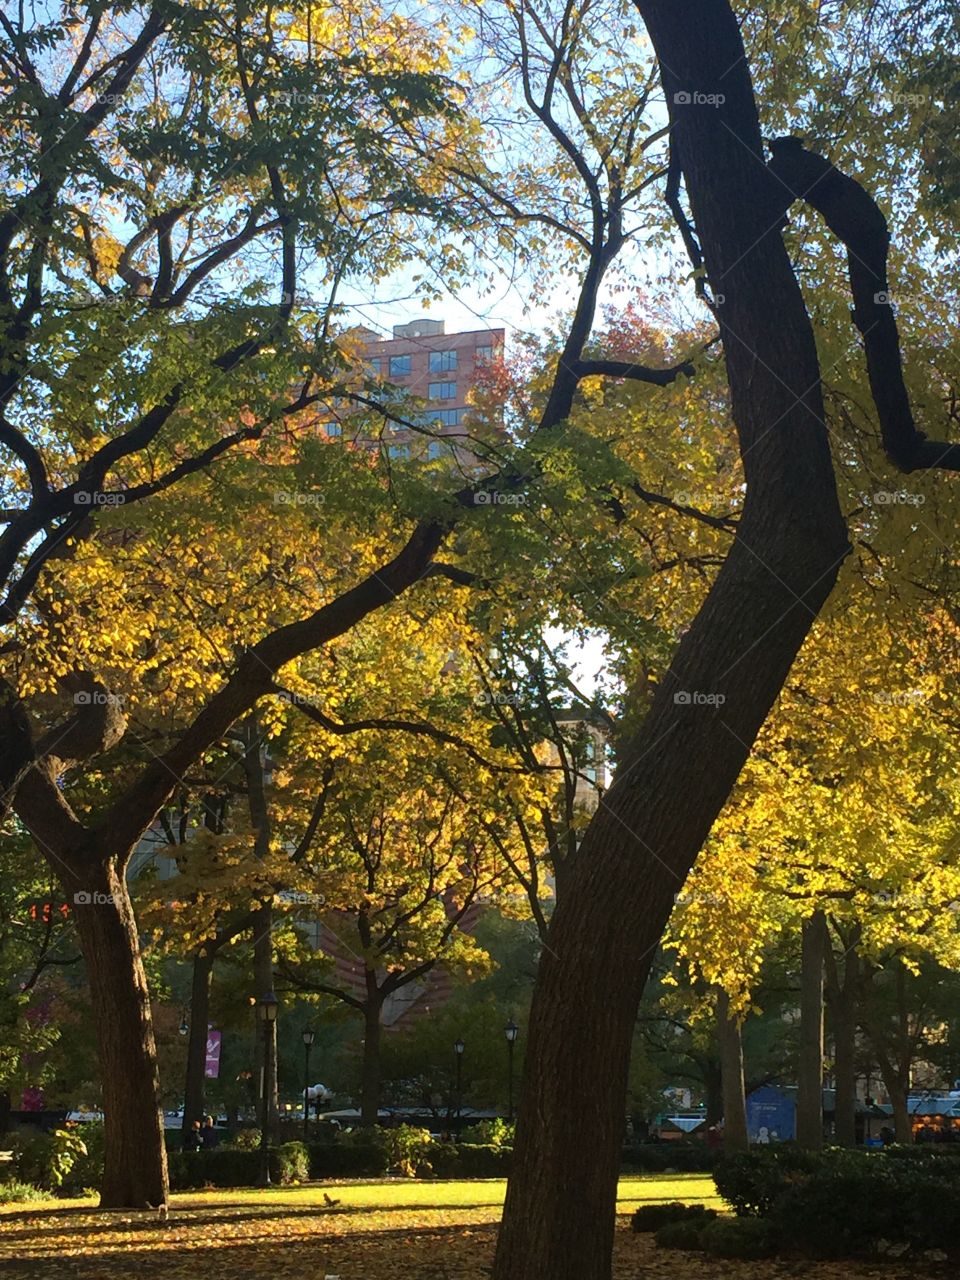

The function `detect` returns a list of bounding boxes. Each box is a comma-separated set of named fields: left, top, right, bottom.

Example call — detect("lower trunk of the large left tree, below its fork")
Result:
left=73, top=864, right=168, bottom=1208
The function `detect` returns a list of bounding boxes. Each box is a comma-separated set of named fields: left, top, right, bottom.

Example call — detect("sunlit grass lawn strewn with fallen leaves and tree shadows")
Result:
left=0, top=1174, right=916, bottom=1280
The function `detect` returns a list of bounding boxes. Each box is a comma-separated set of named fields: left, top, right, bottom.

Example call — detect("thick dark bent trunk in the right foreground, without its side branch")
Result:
left=494, top=0, right=847, bottom=1280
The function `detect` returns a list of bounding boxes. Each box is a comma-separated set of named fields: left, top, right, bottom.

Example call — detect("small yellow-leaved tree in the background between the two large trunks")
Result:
left=282, top=737, right=519, bottom=1125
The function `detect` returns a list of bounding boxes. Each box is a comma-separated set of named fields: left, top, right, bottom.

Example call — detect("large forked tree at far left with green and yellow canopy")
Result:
left=0, top=0, right=471, bottom=1206
